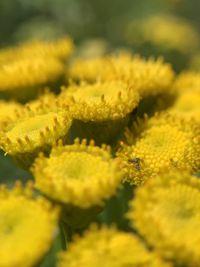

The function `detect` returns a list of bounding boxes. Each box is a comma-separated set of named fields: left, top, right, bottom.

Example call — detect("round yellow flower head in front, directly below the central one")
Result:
left=32, top=139, right=122, bottom=209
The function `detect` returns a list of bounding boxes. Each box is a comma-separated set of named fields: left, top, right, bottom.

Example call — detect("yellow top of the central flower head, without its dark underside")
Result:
left=60, top=81, right=139, bottom=122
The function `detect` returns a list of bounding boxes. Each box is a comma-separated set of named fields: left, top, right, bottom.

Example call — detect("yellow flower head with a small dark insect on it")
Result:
left=118, top=114, right=200, bottom=184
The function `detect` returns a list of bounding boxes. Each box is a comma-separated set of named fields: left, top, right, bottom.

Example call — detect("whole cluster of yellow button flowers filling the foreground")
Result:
left=0, top=36, right=200, bottom=267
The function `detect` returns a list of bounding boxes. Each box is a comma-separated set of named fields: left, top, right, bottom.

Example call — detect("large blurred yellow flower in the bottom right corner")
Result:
left=128, top=172, right=200, bottom=267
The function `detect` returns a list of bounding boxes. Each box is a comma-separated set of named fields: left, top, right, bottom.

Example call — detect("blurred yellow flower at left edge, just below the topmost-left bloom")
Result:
left=0, top=57, right=64, bottom=98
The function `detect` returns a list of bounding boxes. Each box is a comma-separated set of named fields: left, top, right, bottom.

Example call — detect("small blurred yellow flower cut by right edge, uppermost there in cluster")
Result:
left=174, top=71, right=200, bottom=94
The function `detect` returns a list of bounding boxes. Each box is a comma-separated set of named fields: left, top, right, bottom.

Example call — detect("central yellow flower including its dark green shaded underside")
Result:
left=59, top=81, right=139, bottom=144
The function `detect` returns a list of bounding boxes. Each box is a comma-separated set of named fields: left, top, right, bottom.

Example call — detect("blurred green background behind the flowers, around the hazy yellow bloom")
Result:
left=0, top=0, right=200, bottom=71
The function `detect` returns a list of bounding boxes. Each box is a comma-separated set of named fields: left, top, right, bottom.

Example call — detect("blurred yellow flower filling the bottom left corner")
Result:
left=0, top=184, right=58, bottom=267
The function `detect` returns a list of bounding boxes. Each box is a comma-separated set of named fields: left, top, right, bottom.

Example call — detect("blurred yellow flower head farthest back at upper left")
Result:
left=16, top=37, right=74, bottom=59
